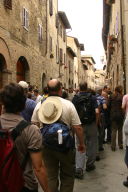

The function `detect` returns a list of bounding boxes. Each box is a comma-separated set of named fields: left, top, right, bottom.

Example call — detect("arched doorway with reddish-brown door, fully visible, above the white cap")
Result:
left=16, top=56, right=30, bottom=82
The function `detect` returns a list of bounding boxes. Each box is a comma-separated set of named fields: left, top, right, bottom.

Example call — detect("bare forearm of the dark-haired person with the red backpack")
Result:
left=30, top=152, right=50, bottom=192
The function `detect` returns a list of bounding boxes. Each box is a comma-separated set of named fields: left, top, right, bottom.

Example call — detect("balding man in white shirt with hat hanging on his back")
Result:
left=32, top=79, right=85, bottom=192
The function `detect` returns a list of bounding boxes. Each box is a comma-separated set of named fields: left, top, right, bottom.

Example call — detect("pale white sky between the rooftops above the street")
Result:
left=58, top=0, right=104, bottom=69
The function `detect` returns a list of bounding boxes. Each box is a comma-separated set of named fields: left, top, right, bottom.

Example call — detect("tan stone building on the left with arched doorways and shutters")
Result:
left=0, top=0, right=74, bottom=90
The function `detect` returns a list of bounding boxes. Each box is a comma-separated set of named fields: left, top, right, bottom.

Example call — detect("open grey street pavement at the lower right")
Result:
left=40, top=144, right=128, bottom=192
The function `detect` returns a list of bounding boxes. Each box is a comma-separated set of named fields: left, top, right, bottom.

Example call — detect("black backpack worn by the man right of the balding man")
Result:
left=73, top=93, right=95, bottom=124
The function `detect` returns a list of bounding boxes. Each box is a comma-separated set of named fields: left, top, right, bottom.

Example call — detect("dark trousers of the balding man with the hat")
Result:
left=42, top=146, right=75, bottom=192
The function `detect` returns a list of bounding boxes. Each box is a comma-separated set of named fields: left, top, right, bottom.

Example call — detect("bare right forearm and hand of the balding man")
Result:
left=73, top=125, right=85, bottom=153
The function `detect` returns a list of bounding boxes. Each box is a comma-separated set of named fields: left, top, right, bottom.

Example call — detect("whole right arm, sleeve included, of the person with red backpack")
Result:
left=24, top=125, right=50, bottom=192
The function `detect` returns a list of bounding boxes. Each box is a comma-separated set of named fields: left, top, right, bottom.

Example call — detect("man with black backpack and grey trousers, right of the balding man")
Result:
left=72, top=82, right=99, bottom=177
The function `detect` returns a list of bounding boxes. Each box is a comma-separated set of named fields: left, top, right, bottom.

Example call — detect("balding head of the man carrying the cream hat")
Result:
left=47, top=79, right=62, bottom=96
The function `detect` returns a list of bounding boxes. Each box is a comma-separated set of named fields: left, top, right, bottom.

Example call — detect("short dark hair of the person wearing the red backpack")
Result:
left=0, top=83, right=26, bottom=113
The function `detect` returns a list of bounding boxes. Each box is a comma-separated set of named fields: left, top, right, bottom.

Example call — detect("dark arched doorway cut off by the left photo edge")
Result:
left=0, top=54, right=7, bottom=89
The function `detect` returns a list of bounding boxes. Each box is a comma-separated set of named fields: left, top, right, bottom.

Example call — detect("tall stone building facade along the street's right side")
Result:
left=102, top=0, right=128, bottom=92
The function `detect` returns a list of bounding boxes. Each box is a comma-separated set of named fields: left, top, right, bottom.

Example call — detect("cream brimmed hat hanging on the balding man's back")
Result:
left=38, top=96, right=62, bottom=124
